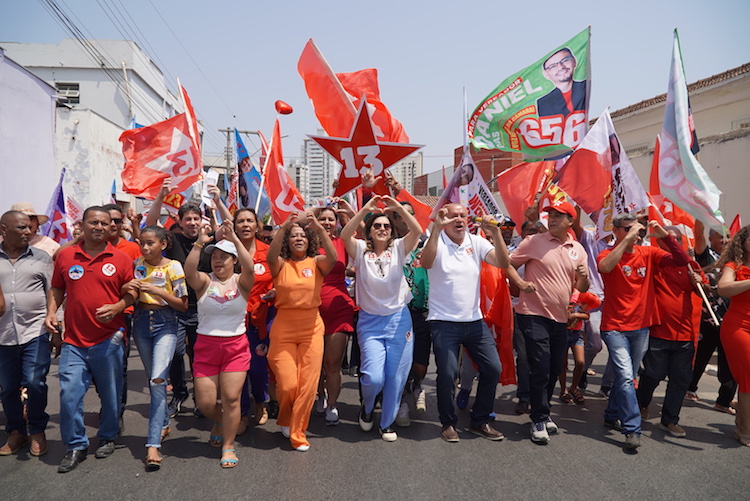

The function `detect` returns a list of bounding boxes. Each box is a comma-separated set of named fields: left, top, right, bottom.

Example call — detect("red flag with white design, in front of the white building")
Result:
left=120, top=113, right=203, bottom=200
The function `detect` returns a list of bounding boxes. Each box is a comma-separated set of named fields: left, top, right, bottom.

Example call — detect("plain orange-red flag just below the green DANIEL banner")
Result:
left=497, top=160, right=555, bottom=228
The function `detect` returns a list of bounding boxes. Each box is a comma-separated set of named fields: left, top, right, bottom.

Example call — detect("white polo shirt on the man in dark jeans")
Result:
left=427, top=231, right=494, bottom=322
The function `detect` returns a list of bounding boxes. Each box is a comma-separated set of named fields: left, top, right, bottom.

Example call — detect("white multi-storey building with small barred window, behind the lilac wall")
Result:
left=0, top=39, right=182, bottom=207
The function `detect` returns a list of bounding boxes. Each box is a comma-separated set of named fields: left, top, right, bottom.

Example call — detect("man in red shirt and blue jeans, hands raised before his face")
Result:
left=597, top=213, right=688, bottom=451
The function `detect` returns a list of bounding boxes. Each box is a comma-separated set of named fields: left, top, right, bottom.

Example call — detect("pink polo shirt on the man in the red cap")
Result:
left=510, top=232, right=588, bottom=324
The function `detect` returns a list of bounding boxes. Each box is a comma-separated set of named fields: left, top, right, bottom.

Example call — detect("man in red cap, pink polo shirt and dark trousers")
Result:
left=510, top=201, right=589, bottom=444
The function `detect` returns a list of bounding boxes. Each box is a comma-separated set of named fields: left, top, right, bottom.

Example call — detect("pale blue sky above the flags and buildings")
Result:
left=0, top=0, right=750, bottom=172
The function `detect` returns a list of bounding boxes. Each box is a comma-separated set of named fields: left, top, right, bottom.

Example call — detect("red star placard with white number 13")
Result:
left=308, top=97, right=424, bottom=197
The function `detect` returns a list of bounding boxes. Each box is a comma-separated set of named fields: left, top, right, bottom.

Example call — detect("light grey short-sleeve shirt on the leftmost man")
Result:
left=0, top=244, right=52, bottom=346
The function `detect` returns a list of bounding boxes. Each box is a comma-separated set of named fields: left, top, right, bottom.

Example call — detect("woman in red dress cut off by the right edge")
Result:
left=716, top=226, right=750, bottom=446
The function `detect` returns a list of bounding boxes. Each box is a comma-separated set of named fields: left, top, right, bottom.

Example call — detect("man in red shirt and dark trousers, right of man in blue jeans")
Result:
left=636, top=226, right=702, bottom=438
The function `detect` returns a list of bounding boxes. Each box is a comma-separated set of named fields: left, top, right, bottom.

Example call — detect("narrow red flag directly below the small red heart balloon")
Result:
left=265, top=118, right=305, bottom=223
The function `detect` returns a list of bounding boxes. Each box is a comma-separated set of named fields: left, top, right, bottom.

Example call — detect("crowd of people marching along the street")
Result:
left=0, top=181, right=750, bottom=473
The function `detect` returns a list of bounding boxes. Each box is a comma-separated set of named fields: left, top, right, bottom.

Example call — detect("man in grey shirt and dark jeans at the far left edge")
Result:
left=0, top=210, right=52, bottom=456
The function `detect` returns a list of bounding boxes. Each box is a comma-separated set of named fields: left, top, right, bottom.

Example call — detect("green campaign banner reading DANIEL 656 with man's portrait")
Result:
left=468, top=28, right=591, bottom=159
